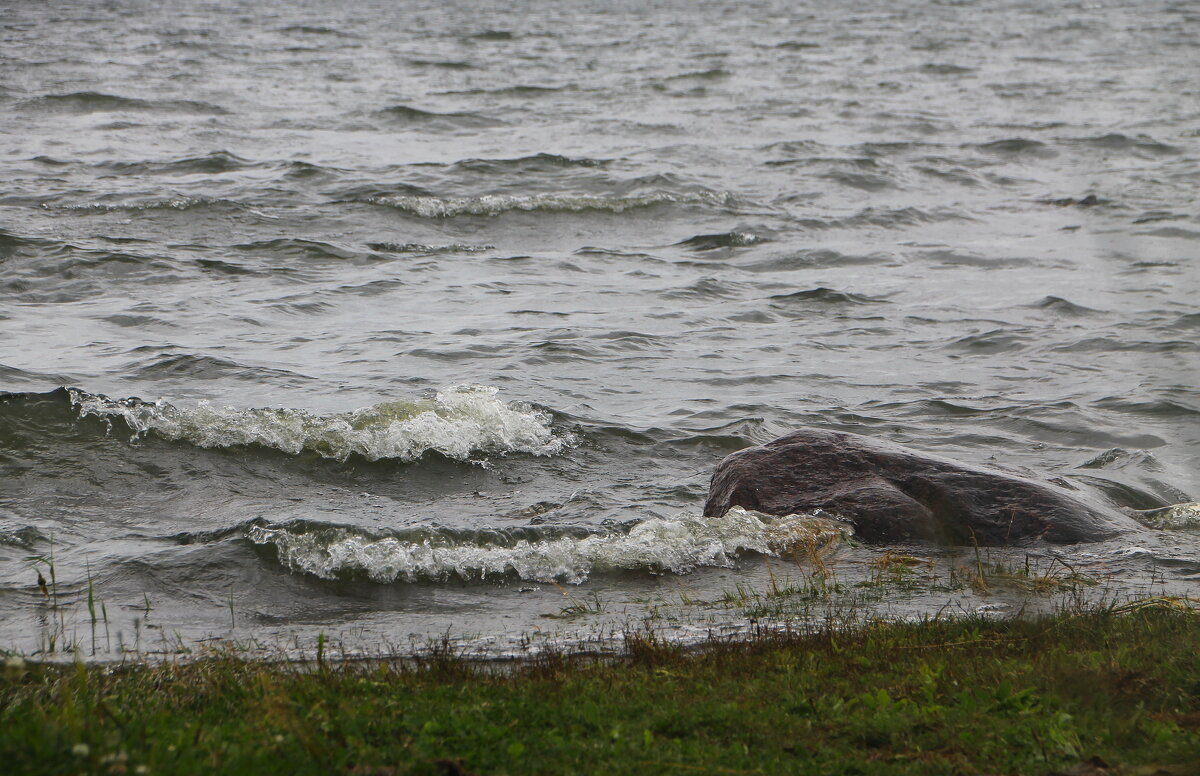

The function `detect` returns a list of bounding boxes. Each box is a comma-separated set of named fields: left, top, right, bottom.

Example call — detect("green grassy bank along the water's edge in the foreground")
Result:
left=0, top=601, right=1200, bottom=775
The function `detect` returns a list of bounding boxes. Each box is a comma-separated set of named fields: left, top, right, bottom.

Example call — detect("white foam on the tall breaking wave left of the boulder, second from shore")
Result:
left=71, top=385, right=572, bottom=461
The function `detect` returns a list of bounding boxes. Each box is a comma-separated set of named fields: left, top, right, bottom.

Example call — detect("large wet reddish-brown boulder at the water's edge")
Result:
left=704, top=428, right=1138, bottom=546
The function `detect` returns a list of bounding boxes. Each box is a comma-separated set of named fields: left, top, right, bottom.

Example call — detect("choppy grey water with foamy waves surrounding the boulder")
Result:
left=0, top=0, right=1200, bottom=655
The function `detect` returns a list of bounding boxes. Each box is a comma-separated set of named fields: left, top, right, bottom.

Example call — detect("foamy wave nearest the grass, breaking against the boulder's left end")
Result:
left=246, top=507, right=850, bottom=583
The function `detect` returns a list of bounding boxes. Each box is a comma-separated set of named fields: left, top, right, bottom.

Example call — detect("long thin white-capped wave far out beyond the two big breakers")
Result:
left=367, top=192, right=732, bottom=218
